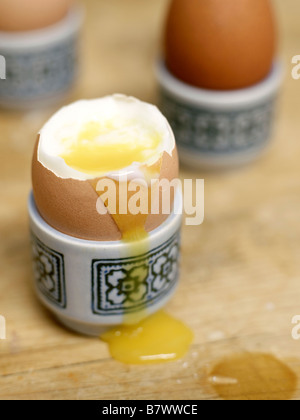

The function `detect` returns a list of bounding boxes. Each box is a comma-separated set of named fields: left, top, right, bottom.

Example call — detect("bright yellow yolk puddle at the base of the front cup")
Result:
left=101, top=311, right=193, bottom=364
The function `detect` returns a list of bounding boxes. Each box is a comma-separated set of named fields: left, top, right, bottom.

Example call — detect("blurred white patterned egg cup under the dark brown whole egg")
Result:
left=157, top=61, right=283, bottom=169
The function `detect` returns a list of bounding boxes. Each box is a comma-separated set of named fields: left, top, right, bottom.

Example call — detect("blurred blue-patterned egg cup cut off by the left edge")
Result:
left=0, top=6, right=84, bottom=109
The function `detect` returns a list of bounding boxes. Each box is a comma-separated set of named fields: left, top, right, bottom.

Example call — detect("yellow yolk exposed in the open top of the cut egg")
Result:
left=60, top=121, right=162, bottom=177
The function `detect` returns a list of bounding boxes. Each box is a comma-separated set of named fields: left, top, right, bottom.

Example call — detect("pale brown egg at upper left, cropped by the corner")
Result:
left=0, top=0, right=73, bottom=31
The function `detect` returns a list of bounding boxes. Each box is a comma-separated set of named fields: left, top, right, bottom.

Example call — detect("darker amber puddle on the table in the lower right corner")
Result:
left=209, top=353, right=297, bottom=401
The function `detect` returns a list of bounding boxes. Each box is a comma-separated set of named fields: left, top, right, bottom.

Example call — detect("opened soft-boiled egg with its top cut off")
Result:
left=32, top=95, right=178, bottom=241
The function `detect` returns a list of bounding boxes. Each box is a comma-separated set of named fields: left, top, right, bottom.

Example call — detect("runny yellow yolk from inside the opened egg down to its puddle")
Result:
left=61, top=122, right=193, bottom=364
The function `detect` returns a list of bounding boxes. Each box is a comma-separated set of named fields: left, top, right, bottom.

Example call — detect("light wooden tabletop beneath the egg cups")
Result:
left=0, top=0, right=300, bottom=399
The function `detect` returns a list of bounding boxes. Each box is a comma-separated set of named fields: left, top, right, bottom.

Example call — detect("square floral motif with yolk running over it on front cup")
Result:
left=92, top=233, right=180, bottom=316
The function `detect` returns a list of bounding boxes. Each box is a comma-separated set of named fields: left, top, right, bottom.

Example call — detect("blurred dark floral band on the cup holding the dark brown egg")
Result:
left=160, top=89, right=275, bottom=156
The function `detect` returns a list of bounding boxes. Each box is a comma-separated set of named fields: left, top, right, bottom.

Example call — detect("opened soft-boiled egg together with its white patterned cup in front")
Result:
left=29, top=95, right=182, bottom=335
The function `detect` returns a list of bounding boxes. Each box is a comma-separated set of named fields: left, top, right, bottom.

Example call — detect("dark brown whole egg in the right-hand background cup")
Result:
left=165, top=0, right=276, bottom=90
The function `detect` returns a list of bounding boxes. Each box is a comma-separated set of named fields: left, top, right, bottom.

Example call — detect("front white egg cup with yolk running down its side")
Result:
left=28, top=191, right=182, bottom=336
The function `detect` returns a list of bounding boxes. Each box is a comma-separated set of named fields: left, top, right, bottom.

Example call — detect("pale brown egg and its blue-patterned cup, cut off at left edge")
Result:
left=0, top=0, right=84, bottom=110
